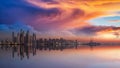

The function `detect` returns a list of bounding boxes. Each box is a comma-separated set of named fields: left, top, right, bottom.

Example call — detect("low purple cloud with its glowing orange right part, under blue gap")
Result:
left=71, top=26, right=120, bottom=36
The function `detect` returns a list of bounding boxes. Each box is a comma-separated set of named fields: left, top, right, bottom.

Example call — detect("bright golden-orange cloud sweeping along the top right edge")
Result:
left=28, top=0, right=120, bottom=20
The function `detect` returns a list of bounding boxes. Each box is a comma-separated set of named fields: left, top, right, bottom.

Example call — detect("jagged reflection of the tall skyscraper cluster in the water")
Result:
left=12, top=45, right=36, bottom=60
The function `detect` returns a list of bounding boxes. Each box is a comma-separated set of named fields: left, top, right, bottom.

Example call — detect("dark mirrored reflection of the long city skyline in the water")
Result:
left=0, top=43, right=78, bottom=60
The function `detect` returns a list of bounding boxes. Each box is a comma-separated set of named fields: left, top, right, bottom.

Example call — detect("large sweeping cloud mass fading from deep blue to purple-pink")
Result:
left=0, top=0, right=85, bottom=31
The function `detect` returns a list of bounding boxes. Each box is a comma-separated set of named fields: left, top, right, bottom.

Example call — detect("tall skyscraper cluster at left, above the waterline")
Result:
left=0, top=30, right=36, bottom=45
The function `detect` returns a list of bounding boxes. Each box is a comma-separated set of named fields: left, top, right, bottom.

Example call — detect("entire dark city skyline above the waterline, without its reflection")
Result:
left=0, top=30, right=78, bottom=46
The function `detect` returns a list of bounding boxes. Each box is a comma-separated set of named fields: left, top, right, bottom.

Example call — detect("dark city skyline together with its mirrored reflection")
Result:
left=0, top=30, right=78, bottom=59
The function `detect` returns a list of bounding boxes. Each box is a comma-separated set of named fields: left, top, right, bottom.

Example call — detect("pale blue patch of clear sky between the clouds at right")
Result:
left=88, top=16, right=120, bottom=27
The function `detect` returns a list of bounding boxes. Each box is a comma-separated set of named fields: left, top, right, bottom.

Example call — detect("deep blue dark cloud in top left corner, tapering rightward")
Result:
left=0, top=0, right=60, bottom=24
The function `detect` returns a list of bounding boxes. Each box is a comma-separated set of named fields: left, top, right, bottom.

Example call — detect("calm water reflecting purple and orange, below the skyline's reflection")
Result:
left=0, top=45, right=120, bottom=68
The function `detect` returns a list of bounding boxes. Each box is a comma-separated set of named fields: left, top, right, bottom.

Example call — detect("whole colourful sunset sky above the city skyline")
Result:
left=0, top=0, right=120, bottom=40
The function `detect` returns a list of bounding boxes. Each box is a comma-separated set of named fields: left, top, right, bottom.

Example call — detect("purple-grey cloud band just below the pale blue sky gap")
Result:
left=71, top=26, right=120, bottom=36
